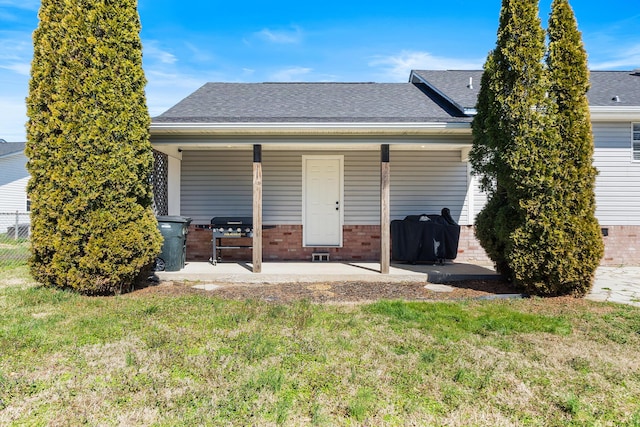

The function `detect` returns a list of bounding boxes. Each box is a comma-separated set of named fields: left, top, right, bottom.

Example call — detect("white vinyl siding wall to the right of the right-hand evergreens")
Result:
left=593, top=122, right=640, bottom=226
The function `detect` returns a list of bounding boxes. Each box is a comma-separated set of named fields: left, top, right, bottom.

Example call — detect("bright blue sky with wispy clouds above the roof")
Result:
left=0, top=0, right=640, bottom=141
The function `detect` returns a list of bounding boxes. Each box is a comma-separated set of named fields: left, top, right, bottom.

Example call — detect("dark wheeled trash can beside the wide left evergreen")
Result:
left=155, top=216, right=191, bottom=271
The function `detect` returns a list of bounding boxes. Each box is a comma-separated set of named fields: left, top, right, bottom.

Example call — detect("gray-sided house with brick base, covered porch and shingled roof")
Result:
left=151, top=71, right=640, bottom=271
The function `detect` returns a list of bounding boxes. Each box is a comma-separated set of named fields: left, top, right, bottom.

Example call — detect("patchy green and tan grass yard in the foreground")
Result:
left=0, top=267, right=640, bottom=426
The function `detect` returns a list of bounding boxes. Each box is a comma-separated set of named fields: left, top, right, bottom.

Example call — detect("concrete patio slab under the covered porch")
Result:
left=156, top=262, right=500, bottom=283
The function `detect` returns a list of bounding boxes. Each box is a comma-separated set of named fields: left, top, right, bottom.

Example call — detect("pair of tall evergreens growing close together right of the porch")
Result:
left=471, top=0, right=602, bottom=295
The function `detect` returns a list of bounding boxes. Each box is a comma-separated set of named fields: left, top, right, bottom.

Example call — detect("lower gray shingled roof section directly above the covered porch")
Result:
left=153, top=83, right=470, bottom=123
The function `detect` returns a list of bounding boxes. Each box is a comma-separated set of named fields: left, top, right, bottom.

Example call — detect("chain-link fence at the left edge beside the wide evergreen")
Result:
left=0, top=212, right=31, bottom=270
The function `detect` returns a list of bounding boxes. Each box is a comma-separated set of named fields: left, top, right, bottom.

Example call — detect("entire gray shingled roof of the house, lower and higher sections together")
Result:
left=153, top=70, right=640, bottom=123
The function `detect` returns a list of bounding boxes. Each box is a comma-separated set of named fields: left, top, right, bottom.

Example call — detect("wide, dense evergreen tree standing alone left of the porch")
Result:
left=26, top=0, right=161, bottom=294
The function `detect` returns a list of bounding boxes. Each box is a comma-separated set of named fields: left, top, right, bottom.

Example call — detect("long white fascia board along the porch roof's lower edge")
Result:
left=150, top=122, right=471, bottom=135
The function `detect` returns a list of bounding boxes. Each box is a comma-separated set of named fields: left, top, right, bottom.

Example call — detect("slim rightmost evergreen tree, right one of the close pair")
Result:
left=543, top=0, right=604, bottom=295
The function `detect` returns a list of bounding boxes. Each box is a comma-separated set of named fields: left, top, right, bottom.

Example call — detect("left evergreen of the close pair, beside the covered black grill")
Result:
left=471, top=0, right=554, bottom=284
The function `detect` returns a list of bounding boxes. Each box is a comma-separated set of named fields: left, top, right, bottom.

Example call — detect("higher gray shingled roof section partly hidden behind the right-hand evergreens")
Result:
left=413, top=70, right=640, bottom=109
